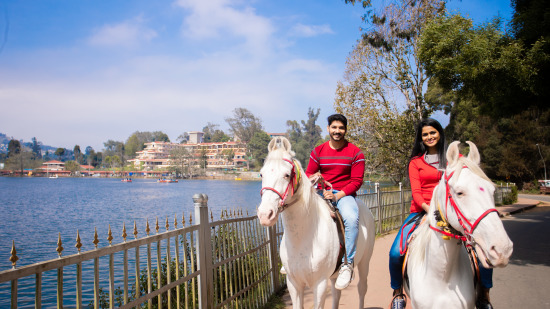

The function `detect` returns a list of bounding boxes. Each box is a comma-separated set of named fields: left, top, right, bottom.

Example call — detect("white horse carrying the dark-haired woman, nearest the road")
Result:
left=405, top=141, right=513, bottom=309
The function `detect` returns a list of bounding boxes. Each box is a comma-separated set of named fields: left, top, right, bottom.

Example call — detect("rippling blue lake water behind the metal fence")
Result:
left=0, top=177, right=388, bottom=308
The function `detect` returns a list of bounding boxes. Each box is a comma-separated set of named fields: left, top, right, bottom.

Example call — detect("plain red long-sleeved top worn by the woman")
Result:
left=409, top=155, right=442, bottom=213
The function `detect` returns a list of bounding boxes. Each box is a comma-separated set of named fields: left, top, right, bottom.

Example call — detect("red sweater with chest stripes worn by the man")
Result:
left=306, top=141, right=365, bottom=195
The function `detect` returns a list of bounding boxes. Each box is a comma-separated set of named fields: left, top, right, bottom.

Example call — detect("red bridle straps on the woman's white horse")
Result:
left=430, top=166, right=497, bottom=246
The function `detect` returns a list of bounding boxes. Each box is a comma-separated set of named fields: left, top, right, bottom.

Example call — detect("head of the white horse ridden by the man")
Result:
left=258, top=137, right=303, bottom=226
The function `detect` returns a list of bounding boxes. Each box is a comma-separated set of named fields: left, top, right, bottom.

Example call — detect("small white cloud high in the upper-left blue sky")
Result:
left=87, top=17, right=157, bottom=47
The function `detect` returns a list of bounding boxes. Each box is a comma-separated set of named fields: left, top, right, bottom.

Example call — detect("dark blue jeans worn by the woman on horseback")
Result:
left=390, top=213, right=493, bottom=290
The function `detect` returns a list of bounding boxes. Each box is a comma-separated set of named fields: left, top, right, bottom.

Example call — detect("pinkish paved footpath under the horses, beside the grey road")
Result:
left=283, top=195, right=548, bottom=309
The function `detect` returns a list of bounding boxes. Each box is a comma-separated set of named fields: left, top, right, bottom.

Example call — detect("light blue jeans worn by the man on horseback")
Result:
left=319, top=190, right=359, bottom=264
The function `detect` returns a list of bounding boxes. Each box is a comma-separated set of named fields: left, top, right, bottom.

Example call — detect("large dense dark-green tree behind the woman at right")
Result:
left=420, top=10, right=550, bottom=187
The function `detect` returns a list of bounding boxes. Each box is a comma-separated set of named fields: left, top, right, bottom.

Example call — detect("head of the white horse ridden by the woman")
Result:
left=438, top=141, right=513, bottom=268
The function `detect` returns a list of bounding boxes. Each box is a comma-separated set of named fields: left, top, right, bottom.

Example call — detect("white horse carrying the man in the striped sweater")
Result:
left=258, top=137, right=375, bottom=309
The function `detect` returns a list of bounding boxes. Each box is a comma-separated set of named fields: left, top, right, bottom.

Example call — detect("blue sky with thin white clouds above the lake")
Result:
left=0, top=0, right=512, bottom=151
